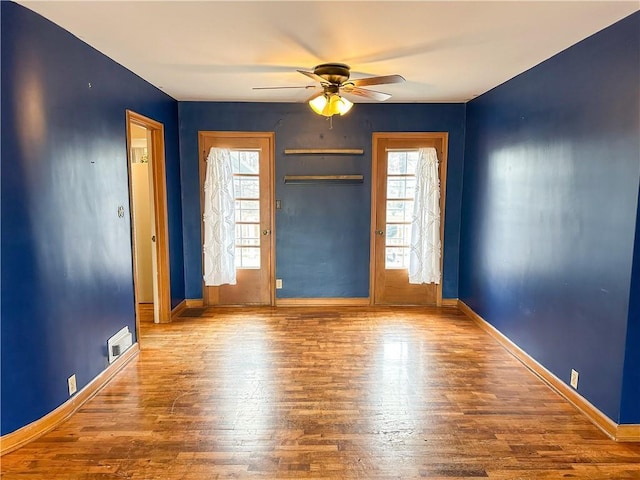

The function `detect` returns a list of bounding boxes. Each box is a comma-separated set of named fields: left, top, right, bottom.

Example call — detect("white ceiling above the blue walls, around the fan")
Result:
left=18, top=0, right=640, bottom=103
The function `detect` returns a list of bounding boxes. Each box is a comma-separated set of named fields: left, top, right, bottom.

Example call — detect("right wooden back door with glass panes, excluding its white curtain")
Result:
left=371, top=133, right=447, bottom=305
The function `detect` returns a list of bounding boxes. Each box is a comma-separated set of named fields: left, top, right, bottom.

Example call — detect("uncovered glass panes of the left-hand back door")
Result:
left=231, top=150, right=261, bottom=269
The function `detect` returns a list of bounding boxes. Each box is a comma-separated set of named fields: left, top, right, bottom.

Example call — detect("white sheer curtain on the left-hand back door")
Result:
left=203, top=148, right=236, bottom=286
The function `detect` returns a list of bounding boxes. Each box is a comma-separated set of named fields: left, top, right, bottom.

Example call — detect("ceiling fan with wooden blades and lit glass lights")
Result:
left=254, top=63, right=404, bottom=117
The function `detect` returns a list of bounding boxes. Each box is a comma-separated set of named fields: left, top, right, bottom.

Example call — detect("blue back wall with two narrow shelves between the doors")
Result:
left=179, top=102, right=465, bottom=298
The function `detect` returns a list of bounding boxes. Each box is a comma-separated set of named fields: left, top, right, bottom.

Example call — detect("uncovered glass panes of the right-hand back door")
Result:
left=385, top=150, right=418, bottom=269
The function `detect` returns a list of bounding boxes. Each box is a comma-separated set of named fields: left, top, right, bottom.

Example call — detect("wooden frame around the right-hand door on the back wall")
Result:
left=369, top=132, right=449, bottom=307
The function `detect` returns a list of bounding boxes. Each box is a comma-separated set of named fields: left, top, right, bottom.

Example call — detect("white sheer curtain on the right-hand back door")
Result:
left=409, top=148, right=440, bottom=283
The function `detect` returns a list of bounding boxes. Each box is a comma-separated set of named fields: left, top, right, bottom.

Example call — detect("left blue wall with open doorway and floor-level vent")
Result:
left=0, top=2, right=184, bottom=434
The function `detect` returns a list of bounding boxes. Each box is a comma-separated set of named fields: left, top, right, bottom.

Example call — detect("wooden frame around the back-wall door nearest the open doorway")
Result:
left=198, top=130, right=276, bottom=306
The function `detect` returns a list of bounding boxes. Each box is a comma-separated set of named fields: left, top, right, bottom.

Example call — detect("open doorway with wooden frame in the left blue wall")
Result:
left=127, top=111, right=171, bottom=332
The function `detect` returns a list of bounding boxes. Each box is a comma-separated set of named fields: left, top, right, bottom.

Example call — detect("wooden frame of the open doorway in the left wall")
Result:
left=126, top=110, right=171, bottom=330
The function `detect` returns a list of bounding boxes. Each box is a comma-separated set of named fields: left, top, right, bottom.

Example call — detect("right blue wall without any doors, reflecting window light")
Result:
left=459, top=13, right=640, bottom=423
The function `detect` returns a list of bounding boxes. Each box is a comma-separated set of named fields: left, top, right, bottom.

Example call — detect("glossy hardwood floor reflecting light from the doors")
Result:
left=1, top=307, right=640, bottom=480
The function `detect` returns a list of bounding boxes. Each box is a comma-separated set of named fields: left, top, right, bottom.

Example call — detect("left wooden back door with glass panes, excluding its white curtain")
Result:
left=199, top=132, right=275, bottom=305
